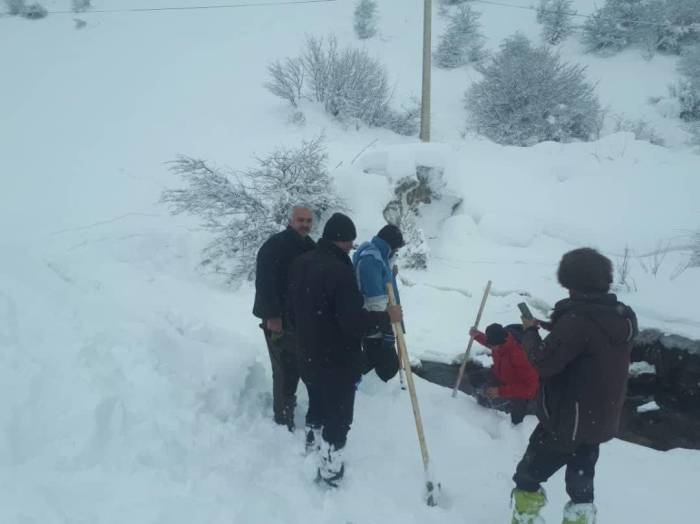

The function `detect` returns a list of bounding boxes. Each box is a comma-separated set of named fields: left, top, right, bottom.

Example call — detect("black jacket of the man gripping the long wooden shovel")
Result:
left=288, top=238, right=390, bottom=378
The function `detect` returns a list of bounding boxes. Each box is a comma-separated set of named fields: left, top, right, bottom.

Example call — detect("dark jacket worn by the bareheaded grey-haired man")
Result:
left=253, top=227, right=315, bottom=320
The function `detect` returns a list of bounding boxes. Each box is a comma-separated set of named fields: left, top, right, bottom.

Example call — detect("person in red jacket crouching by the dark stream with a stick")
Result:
left=469, top=324, right=540, bottom=424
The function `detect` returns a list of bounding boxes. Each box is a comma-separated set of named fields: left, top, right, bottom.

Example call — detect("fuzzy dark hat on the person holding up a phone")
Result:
left=557, top=247, right=613, bottom=293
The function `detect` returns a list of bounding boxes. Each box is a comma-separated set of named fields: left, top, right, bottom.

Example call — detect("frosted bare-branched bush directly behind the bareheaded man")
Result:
left=161, top=137, right=344, bottom=283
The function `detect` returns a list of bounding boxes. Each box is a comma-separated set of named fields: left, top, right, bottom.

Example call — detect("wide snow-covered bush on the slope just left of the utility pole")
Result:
left=265, top=36, right=419, bottom=134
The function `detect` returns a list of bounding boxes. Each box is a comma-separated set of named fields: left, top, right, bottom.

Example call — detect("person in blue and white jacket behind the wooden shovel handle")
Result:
left=352, top=224, right=405, bottom=382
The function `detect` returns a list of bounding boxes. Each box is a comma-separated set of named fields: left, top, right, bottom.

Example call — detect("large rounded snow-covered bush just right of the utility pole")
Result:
left=465, top=34, right=602, bottom=146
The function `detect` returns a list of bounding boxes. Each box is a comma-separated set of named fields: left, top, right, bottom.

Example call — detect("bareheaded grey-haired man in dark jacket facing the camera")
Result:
left=253, top=206, right=315, bottom=431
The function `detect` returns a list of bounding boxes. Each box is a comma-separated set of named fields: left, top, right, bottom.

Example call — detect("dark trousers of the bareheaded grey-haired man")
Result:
left=264, top=329, right=299, bottom=429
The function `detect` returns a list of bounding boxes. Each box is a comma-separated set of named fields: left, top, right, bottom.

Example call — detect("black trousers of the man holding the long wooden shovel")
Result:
left=303, top=369, right=358, bottom=449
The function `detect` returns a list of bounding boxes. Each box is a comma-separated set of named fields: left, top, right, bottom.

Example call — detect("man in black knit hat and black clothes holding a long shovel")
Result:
left=289, top=213, right=402, bottom=486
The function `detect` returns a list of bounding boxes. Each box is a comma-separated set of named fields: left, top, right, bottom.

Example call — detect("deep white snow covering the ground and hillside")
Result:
left=0, top=0, right=700, bottom=524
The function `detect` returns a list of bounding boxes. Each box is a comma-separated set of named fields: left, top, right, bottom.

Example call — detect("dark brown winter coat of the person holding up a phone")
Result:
left=523, top=292, right=637, bottom=446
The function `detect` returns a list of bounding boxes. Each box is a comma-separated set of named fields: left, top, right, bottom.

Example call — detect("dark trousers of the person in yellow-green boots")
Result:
left=513, top=424, right=599, bottom=504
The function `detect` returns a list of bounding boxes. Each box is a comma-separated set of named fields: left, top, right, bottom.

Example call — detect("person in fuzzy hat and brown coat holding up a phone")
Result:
left=513, top=248, right=637, bottom=524
